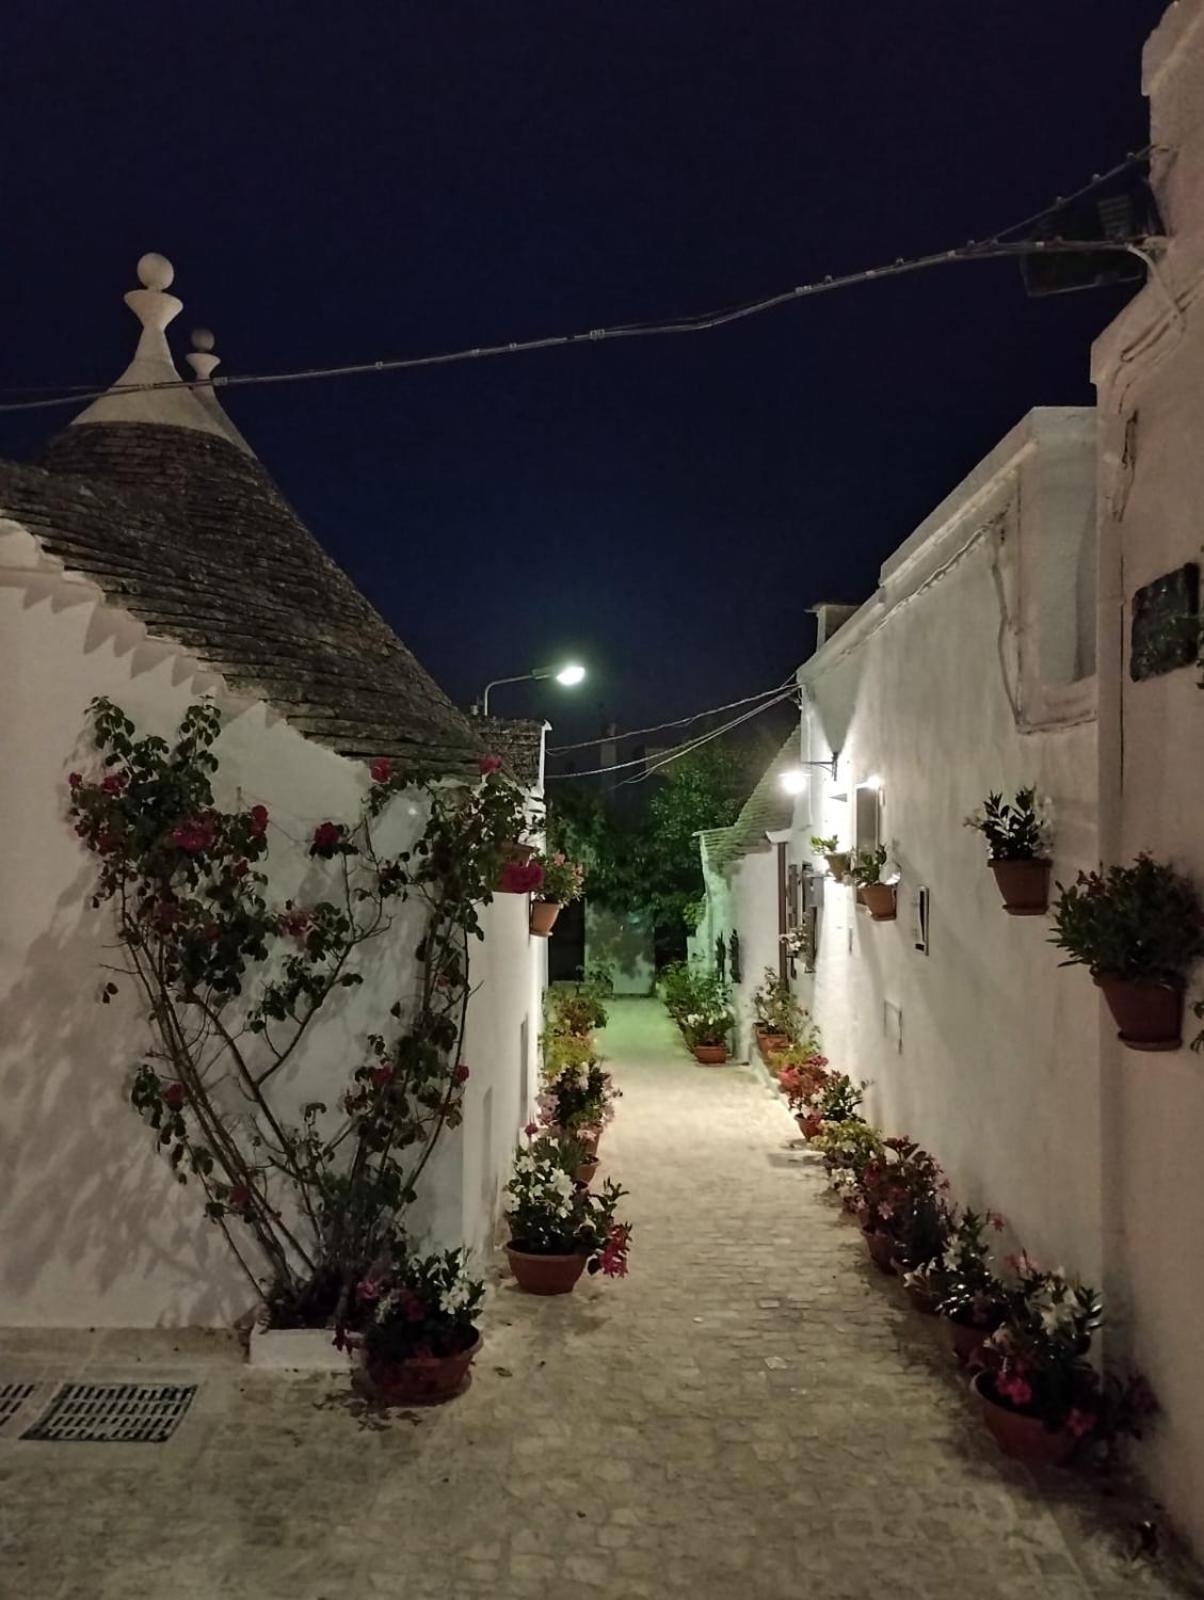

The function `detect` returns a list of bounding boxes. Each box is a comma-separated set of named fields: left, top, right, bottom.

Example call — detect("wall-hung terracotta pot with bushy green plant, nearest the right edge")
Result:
left=1052, top=854, right=1204, bottom=1050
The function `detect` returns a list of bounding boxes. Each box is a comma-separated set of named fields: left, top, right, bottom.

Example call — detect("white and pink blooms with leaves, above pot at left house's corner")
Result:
left=506, top=1134, right=631, bottom=1278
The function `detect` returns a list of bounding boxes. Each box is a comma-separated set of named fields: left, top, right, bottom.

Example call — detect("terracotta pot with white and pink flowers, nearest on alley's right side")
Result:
left=972, top=1256, right=1154, bottom=1466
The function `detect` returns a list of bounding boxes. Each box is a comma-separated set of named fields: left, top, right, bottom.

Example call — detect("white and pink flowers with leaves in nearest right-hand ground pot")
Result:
left=983, top=1254, right=1156, bottom=1442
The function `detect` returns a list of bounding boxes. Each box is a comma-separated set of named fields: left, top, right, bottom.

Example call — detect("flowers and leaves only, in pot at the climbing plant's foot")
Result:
left=355, top=1243, right=485, bottom=1362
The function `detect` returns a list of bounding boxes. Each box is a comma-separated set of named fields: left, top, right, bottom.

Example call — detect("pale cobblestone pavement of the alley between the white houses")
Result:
left=0, top=1002, right=1204, bottom=1600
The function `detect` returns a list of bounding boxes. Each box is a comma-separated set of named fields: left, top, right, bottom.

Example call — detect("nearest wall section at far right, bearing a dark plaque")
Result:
left=1094, top=0, right=1204, bottom=1552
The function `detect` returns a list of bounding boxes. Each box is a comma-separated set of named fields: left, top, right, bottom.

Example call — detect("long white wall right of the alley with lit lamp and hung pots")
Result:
left=793, top=411, right=1102, bottom=1278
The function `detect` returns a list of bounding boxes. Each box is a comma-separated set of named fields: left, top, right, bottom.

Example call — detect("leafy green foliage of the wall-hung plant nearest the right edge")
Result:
left=1050, top=854, right=1204, bottom=987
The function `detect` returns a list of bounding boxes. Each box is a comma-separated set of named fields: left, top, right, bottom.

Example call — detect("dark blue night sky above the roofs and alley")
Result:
left=0, top=0, right=1164, bottom=738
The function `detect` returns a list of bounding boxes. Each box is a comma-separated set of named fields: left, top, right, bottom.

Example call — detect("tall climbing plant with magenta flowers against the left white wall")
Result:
left=69, top=699, right=522, bottom=1323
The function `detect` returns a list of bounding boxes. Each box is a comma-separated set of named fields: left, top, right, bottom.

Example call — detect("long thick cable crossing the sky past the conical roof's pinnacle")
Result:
left=0, top=150, right=1146, bottom=413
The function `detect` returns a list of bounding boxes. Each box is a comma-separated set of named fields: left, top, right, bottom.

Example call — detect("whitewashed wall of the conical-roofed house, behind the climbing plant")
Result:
left=0, top=521, right=543, bottom=1326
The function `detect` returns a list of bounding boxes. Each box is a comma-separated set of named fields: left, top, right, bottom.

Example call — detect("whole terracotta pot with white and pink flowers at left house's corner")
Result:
left=506, top=1134, right=631, bottom=1294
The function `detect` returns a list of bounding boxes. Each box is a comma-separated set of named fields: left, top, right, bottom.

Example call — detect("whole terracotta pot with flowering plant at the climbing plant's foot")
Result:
left=352, top=1243, right=485, bottom=1405
